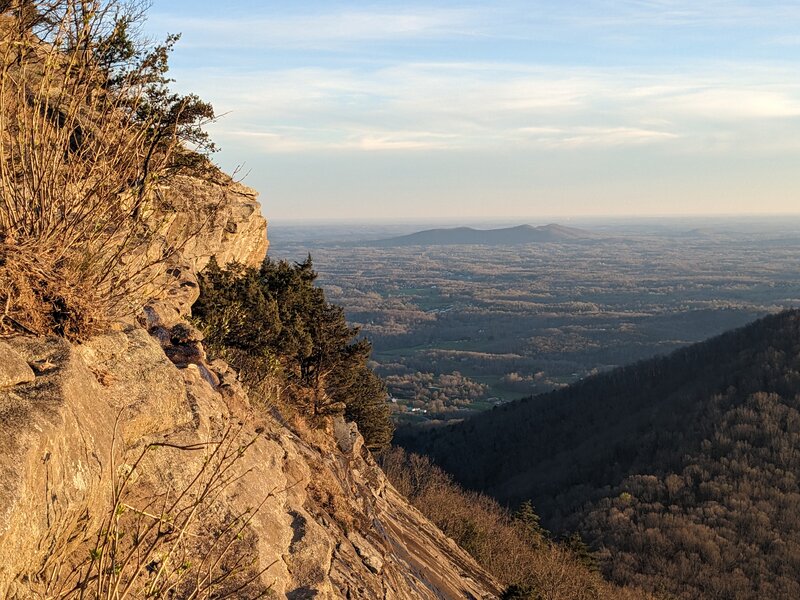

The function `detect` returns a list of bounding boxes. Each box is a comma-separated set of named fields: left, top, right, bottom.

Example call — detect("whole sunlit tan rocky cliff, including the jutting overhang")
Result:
left=0, top=178, right=498, bottom=600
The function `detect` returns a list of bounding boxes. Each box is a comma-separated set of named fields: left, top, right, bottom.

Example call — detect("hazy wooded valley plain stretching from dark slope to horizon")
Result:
left=271, top=217, right=800, bottom=422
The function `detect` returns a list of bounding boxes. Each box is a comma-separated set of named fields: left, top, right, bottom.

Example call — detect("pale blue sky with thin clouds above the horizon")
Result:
left=145, top=0, right=800, bottom=223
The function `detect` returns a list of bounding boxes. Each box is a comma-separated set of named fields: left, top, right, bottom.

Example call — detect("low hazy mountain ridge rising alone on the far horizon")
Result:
left=365, top=223, right=596, bottom=247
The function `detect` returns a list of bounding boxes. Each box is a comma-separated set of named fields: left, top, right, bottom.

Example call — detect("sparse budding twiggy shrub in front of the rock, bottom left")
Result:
left=30, top=425, right=279, bottom=600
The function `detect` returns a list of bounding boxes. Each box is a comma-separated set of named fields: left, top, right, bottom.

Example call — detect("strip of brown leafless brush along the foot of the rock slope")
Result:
left=379, top=448, right=651, bottom=600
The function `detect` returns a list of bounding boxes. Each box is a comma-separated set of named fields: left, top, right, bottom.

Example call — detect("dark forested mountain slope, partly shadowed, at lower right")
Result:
left=399, top=311, right=800, bottom=600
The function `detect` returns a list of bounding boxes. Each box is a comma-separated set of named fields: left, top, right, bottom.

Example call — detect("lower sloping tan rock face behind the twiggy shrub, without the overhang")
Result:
left=0, top=328, right=498, bottom=599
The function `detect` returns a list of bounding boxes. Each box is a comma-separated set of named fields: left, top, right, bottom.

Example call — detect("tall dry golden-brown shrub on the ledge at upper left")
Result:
left=0, top=0, right=209, bottom=338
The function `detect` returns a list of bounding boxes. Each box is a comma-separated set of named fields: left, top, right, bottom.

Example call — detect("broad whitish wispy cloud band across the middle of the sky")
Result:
left=184, top=63, right=800, bottom=152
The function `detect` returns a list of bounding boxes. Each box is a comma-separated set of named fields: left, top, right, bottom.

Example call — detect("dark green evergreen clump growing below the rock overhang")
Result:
left=193, top=256, right=394, bottom=448
